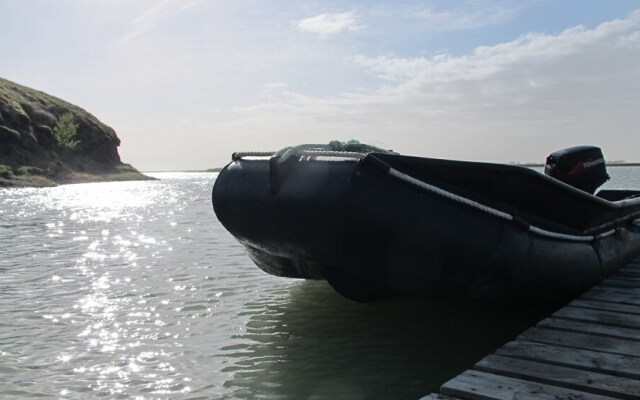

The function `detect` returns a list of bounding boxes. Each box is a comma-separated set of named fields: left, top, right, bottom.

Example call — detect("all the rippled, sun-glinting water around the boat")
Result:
left=0, top=168, right=640, bottom=399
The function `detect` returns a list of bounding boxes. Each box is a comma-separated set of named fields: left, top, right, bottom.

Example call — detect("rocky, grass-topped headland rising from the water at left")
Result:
left=0, top=78, right=146, bottom=186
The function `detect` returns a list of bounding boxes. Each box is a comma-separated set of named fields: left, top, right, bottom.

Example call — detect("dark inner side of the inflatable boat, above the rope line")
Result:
left=370, top=153, right=640, bottom=234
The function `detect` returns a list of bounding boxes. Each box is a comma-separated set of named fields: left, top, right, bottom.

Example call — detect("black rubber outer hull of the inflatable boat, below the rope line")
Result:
left=213, top=156, right=640, bottom=304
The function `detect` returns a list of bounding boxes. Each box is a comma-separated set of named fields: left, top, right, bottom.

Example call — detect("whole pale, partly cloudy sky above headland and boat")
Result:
left=0, top=0, right=640, bottom=171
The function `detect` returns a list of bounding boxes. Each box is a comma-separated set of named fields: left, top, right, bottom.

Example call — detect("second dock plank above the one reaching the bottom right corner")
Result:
left=517, top=327, right=640, bottom=357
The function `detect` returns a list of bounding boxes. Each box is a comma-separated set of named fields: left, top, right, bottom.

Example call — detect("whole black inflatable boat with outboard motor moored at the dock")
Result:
left=213, top=146, right=640, bottom=304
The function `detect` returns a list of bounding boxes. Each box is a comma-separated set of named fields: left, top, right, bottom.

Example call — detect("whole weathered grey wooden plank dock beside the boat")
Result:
left=422, top=259, right=640, bottom=400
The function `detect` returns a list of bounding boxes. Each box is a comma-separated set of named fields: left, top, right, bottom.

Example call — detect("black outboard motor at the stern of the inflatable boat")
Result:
left=544, top=146, right=609, bottom=194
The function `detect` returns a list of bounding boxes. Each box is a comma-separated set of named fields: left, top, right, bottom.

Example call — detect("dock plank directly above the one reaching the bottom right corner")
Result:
left=496, top=341, right=640, bottom=379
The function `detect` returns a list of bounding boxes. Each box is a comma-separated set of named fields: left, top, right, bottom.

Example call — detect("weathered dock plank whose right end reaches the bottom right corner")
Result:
left=474, top=355, right=640, bottom=399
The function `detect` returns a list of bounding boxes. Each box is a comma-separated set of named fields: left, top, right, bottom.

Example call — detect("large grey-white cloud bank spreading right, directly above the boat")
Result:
left=226, top=12, right=640, bottom=161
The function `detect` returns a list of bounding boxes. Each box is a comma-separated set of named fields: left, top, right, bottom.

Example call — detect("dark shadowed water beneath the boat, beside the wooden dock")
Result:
left=222, top=282, right=553, bottom=399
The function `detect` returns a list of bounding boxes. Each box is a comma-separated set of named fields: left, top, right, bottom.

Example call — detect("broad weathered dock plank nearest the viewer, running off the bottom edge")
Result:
left=440, top=371, right=613, bottom=400
